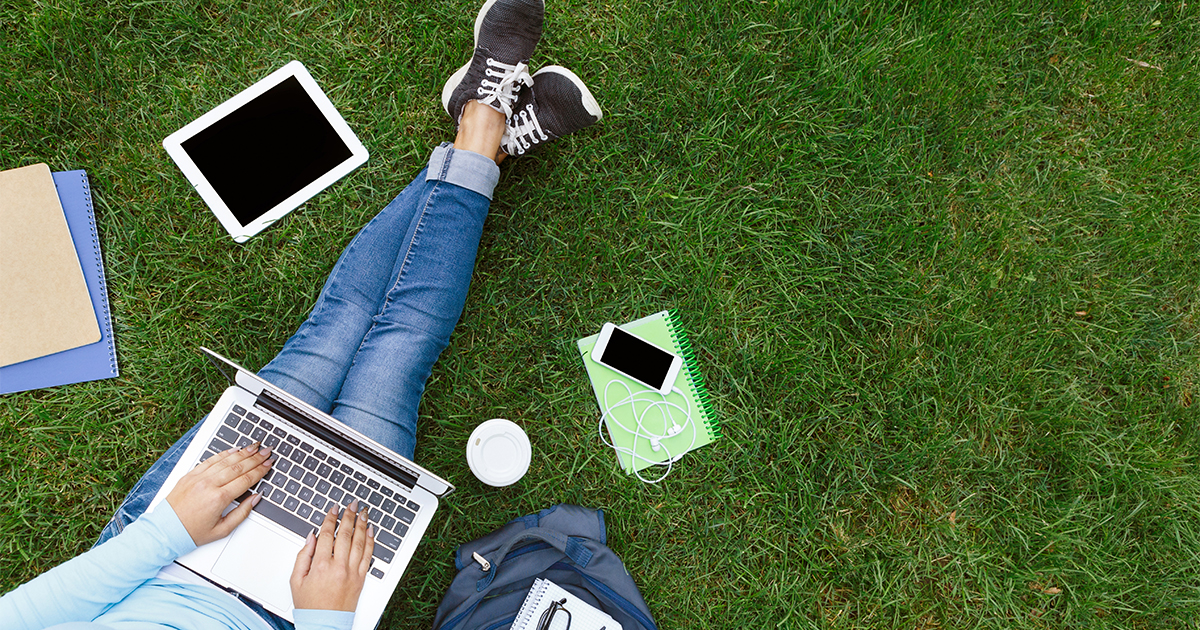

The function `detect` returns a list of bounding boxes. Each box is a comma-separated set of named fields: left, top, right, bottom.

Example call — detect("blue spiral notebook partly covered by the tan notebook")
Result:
left=0, top=170, right=118, bottom=394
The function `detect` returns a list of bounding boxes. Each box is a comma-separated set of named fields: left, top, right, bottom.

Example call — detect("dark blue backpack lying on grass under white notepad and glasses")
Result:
left=433, top=504, right=658, bottom=630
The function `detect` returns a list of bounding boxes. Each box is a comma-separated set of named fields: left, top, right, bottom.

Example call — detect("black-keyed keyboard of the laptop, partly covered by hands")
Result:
left=200, top=404, right=421, bottom=577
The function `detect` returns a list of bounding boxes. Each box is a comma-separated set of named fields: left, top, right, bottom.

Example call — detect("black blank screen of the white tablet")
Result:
left=181, top=77, right=352, bottom=226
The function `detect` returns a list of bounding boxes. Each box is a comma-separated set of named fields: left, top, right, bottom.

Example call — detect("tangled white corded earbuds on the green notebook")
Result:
left=596, top=379, right=700, bottom=484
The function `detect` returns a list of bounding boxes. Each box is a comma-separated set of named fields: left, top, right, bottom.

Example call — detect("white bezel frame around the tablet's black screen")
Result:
left=162, top=61, right=367, bottom=242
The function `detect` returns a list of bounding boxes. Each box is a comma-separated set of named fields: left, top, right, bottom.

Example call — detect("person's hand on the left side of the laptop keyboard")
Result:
left=167, top=442, right=275, bottom=546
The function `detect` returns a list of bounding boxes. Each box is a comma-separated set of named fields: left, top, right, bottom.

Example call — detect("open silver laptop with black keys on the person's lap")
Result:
left=151, top=348, right=454, bottom=630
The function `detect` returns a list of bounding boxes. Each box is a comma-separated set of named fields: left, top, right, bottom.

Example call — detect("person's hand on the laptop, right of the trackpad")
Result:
left=292, top=499, right=374, bottom=612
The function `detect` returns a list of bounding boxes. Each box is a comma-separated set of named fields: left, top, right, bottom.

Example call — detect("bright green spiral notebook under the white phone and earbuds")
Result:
left=575, top=310, right=721, bottom=473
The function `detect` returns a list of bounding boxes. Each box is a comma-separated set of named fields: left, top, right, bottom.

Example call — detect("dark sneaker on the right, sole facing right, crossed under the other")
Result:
left=500, top=66, right=604, bottom=156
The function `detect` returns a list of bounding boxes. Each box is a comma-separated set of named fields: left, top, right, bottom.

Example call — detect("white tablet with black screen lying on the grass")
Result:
left=162, top=61, right=367, bottom=242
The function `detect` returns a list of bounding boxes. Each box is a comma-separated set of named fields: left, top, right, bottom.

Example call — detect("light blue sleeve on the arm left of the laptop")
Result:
left=0, top=502, right=196, bottom=630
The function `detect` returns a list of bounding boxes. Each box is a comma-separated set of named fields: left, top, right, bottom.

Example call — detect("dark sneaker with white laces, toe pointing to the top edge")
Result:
left=442, top=0, right=546, bottom=126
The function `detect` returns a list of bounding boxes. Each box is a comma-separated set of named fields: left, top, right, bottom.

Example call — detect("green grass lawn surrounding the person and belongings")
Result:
left=0, top=0, right=1200, bottom=629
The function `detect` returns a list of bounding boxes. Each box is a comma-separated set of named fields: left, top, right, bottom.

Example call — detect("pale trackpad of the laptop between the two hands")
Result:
left=212, top=518, right=304, bottom=611
